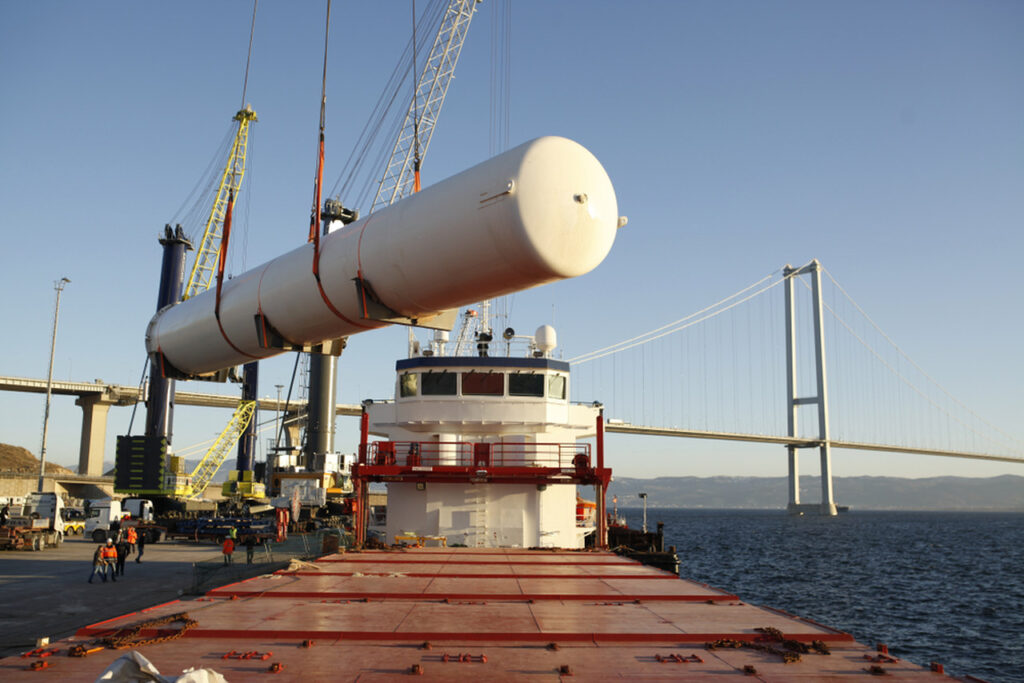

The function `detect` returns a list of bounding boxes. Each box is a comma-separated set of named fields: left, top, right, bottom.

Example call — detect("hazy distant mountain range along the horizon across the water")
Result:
left=608, top=474, right=1024, bottom=512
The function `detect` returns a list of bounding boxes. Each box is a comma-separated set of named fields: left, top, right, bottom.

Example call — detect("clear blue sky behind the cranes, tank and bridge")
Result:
left=0, top=0, right=1024, bottom=476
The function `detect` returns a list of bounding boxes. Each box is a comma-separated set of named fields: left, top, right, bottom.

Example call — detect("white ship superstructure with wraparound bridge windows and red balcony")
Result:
left=355, top=328, right=609, bottom=548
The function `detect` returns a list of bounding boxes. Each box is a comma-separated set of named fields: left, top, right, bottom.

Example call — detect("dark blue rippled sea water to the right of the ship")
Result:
left=620, top=508, right=1024, bottom=683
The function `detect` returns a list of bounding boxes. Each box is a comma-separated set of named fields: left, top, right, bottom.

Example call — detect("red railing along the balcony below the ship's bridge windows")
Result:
left=359, top=441, right=591, bottom=469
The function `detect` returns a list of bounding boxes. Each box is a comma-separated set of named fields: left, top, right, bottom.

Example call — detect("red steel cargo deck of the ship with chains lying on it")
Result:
left=0, top=548, right=958, bottom=681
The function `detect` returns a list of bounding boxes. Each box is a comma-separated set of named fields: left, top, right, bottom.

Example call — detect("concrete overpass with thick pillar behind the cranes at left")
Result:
left=0, top=376, right=362, bottom=476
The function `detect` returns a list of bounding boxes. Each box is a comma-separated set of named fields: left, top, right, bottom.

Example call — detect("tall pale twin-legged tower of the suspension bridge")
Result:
left=782, top=259, right=836, bottom=515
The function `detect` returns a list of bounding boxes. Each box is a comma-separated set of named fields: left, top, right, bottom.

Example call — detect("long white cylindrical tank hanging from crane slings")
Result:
left=146, top=137, right=618, bottom=375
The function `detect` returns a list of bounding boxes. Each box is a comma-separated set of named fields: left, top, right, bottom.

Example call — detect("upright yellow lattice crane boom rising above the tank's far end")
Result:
left=181, top=104, right=259, bottom=300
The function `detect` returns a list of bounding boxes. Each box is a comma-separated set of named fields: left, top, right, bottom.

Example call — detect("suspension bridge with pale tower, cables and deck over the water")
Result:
left=569, top=260, right=1024, bottom=514
